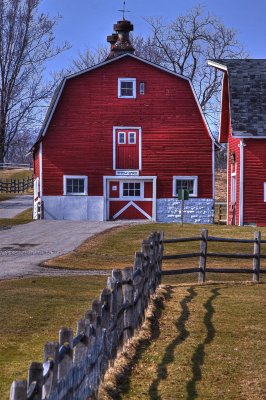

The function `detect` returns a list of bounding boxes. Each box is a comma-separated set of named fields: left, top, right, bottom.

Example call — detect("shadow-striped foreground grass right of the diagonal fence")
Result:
left=101, top=284, right=266, bottom=400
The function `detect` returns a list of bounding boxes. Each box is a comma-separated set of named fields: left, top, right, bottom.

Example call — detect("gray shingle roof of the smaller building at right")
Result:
left=210, top=59, right=266, bottom=137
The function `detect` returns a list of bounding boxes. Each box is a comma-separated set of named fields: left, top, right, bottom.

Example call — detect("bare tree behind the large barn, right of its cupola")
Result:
left=143, top=6, right=247, bottom=127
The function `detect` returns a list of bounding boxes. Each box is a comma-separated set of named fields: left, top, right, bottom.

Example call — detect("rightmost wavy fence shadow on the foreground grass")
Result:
left=187, top=289, right=221, bottom=400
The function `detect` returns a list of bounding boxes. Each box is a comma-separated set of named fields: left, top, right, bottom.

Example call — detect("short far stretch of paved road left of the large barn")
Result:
left=0, top=195, right=33, bottom=218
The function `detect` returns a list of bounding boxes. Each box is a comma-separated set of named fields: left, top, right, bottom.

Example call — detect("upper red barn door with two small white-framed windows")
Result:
left=115, top=129, right=140, bottom=170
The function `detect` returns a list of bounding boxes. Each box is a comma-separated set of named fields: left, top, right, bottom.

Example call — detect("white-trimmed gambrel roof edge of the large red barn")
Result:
left=32, top=53, right=216, bottom=150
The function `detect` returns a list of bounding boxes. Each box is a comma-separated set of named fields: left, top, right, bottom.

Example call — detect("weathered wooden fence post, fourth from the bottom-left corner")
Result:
left=58, top=328, right=73, bottom=379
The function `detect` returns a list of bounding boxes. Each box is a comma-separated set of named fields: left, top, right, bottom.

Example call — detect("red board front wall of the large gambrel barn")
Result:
left=39, top=57, right=212, bottom=198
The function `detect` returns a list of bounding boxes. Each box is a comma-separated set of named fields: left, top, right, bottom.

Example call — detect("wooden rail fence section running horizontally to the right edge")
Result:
left=162, top=230, right=266, bottom=283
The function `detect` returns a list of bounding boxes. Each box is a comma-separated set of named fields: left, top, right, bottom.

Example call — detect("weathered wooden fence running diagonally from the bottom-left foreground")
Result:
left=10, top=233, right=163, bottom=400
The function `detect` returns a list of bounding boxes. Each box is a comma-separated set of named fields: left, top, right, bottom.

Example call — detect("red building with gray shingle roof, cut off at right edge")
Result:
left=209, top=59, right=266, bottom=226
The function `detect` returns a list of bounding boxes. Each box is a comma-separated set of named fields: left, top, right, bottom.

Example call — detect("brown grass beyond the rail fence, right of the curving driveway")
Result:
left=45, top=224, right=266, bottom=279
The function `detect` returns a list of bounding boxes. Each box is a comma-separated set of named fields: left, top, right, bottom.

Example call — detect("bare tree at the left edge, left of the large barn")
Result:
left=0, top=0, right=69, bottom=163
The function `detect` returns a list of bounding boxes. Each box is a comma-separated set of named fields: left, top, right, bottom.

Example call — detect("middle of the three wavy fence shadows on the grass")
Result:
left=149, top=287, right=197, bottom=400
